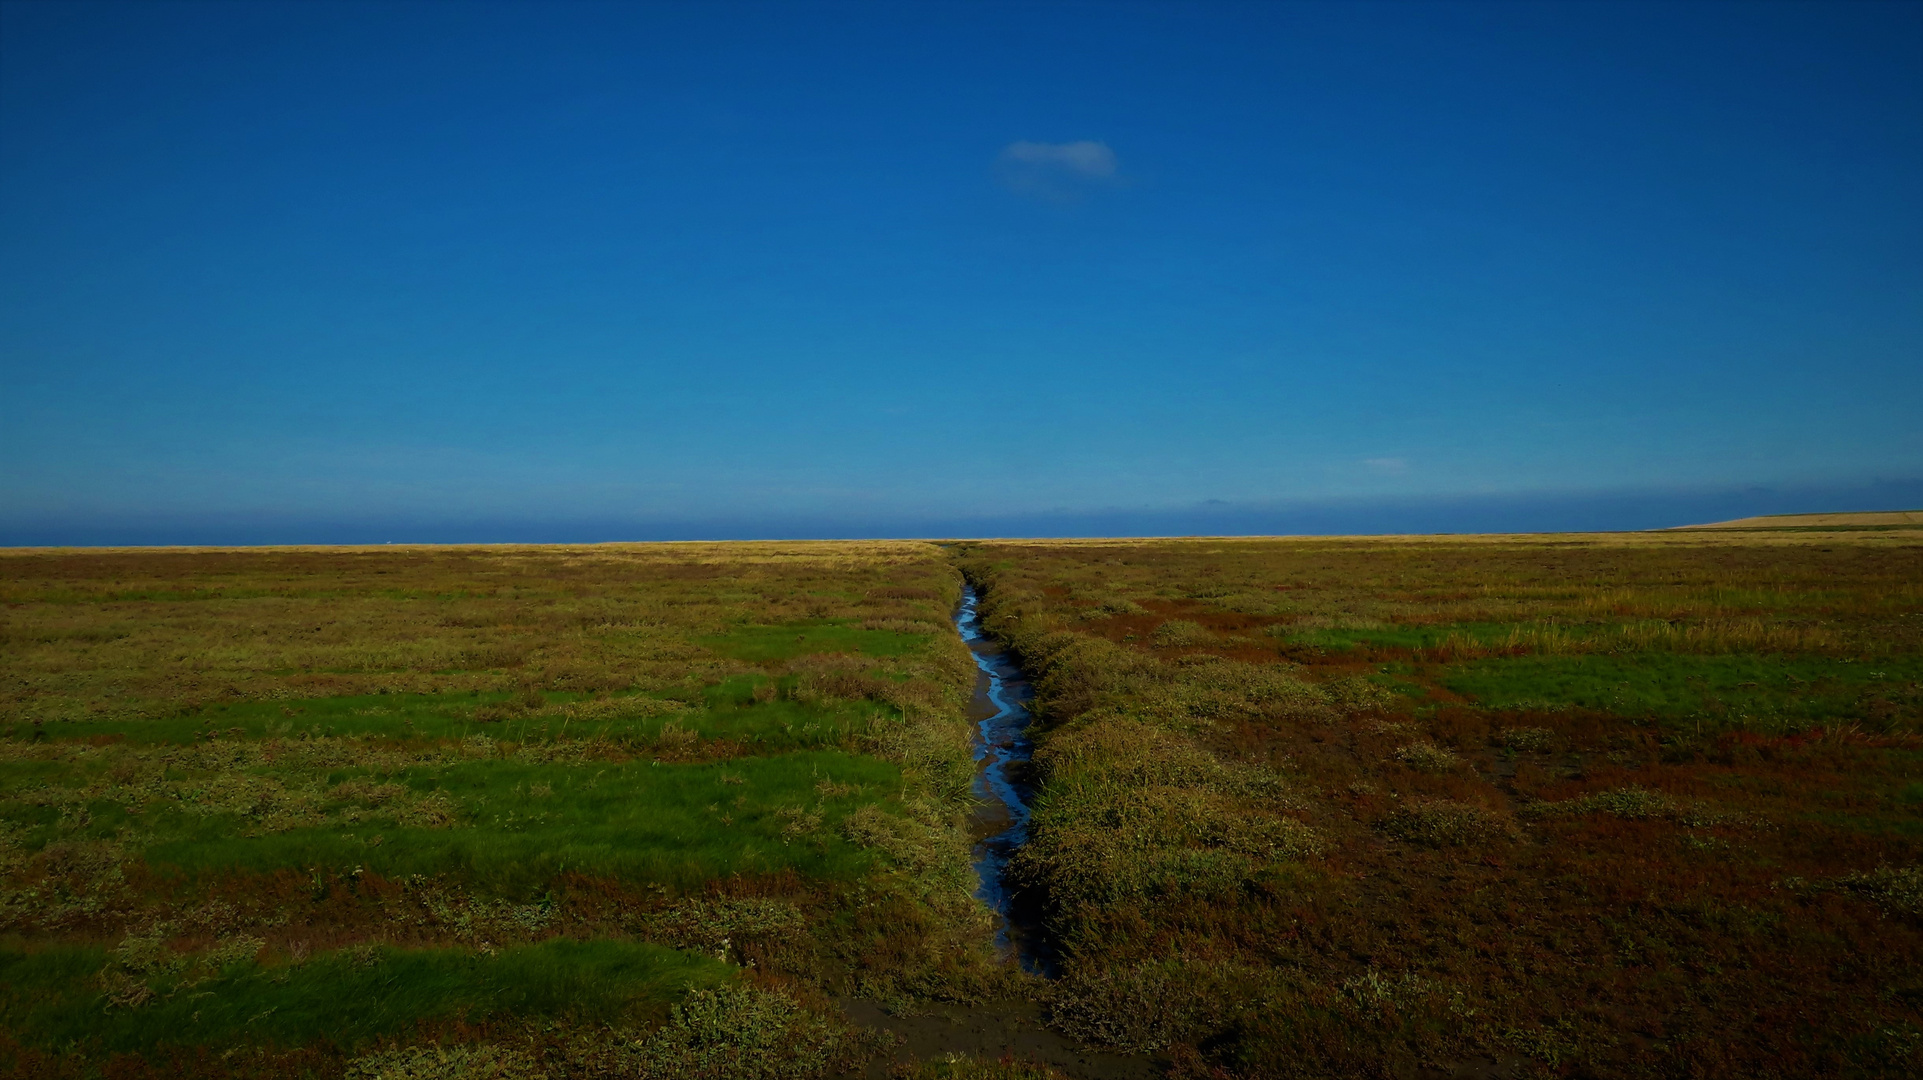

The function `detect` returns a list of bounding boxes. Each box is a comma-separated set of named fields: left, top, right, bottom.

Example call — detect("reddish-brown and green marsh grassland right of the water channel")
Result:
left=962, top=530, right=1923, bottom=1078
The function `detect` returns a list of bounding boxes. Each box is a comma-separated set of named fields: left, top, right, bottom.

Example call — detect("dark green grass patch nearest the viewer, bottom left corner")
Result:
left=0, top=940, right=735, bottom=1053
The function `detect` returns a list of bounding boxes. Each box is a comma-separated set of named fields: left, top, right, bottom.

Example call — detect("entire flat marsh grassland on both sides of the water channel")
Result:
left=0, top=528, right=1923, bottom=1080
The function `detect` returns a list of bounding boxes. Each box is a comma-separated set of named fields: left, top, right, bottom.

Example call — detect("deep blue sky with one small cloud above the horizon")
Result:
left=0, top=0, right=1923, bottom=542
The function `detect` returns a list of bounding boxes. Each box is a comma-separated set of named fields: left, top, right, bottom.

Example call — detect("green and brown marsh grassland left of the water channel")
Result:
left=0, top=544, right=1008, bottom=1076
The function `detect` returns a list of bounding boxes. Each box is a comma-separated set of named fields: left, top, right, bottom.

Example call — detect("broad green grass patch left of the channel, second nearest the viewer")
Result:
left=114, top=749, right=902, bottom=894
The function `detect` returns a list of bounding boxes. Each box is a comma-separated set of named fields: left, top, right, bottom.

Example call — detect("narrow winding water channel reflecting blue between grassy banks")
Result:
left=956, top=584, right=1054, bottom=976
